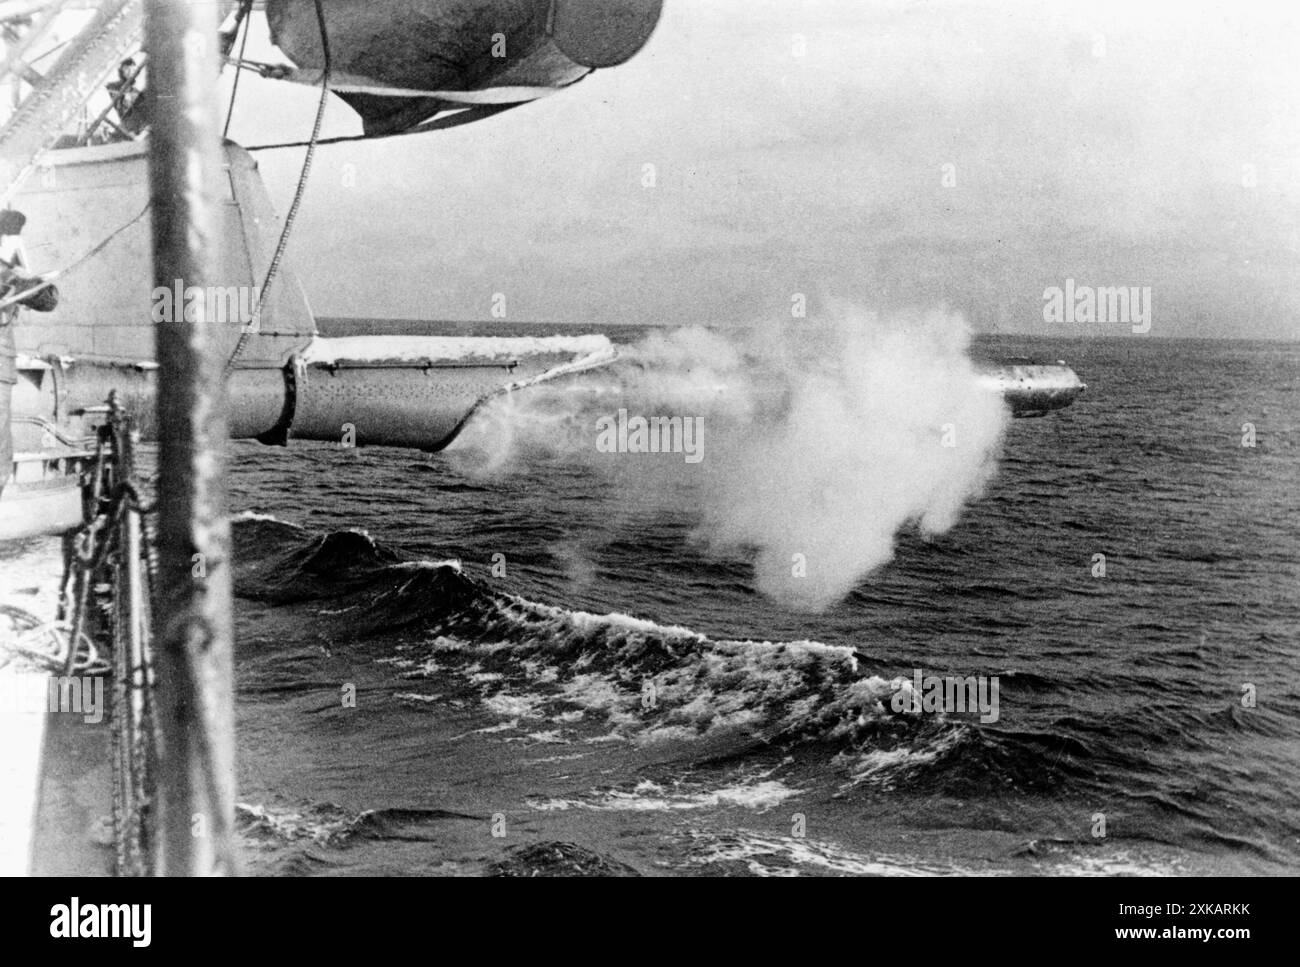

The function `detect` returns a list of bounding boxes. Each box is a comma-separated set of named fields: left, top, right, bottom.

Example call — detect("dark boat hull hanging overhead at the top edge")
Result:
left=267, top=0, right=662, bottom=136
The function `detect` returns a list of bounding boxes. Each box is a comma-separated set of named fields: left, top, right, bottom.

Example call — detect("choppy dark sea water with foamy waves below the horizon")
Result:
left=233, top=328, right=1300, bottom=875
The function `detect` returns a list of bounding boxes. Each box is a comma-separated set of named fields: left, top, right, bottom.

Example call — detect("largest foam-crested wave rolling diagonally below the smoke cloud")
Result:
left=228, top=519, right=1092, bottom=805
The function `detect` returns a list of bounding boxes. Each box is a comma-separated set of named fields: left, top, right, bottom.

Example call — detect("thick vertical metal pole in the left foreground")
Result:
left=142, top=0, right=235, bottom=876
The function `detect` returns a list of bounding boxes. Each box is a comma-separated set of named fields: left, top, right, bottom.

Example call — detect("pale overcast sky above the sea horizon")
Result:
left=231, top=0, right=1300, bottom=338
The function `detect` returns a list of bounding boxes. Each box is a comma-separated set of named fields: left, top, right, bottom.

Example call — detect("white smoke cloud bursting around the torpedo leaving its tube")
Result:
left=455, top=305, right=1008, bottom=611
